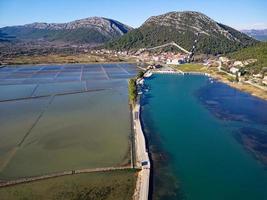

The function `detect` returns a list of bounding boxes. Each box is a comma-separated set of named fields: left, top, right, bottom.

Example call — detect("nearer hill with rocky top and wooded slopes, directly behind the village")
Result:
left=108, top=11, right=256, bottom=54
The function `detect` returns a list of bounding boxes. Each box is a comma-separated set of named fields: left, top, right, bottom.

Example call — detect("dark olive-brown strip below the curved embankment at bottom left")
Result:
left=0, top=170, right=136, bottom=200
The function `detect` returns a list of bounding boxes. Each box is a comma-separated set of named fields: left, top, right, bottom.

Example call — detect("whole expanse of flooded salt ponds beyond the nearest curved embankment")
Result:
left=0, top=64, right=136, bottom=180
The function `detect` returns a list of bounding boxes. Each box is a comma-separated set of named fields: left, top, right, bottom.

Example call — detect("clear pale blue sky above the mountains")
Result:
left=0, top=0, right=267, bottom=30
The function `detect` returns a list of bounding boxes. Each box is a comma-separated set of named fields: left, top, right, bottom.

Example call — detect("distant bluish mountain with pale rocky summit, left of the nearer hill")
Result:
left=0, top=17, right=132, bottom=44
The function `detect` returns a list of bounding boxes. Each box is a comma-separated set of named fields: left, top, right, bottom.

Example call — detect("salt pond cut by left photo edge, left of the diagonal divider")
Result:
left=0, top=98, right=49, bottom=173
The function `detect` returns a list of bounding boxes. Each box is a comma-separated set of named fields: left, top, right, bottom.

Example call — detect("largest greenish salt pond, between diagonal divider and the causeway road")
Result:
left=0, top=89, right=131, bottom=178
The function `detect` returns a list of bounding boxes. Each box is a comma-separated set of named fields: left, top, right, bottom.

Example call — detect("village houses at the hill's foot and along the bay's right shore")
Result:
left=90, top=49, right=267, bottom=87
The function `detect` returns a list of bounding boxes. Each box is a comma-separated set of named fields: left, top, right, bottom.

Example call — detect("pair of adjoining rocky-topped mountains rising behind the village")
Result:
left=0, top=11, right=257, bottom=54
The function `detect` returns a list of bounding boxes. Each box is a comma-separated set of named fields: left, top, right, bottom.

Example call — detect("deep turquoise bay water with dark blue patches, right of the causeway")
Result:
left=142, top=75, right=267, bottom=200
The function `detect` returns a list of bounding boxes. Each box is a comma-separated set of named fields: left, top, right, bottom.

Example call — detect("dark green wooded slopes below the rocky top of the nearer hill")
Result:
left=106, top=24, right=256, bottom=54
